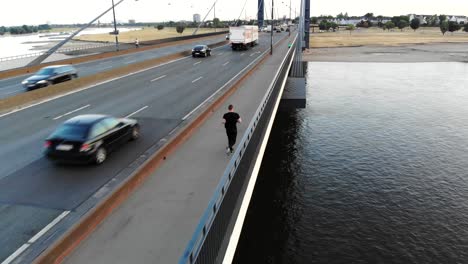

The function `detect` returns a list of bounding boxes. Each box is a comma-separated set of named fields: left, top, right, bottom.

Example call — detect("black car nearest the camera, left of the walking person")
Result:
left=44, top=115, right=140, bottom=164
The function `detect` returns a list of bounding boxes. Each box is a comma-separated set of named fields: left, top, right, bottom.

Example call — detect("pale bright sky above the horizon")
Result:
left=0, top=0, right=468, bottom=26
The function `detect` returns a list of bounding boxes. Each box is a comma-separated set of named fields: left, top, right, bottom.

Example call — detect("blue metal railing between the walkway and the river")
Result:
left=179, top=36, right=297, bottom=264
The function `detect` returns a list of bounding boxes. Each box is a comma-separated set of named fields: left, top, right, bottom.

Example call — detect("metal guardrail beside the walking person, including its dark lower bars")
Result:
left=178, top=36, right=297, bottom=264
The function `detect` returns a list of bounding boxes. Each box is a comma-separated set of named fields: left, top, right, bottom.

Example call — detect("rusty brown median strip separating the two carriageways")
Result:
left=0, top=41, right=227, bottom=113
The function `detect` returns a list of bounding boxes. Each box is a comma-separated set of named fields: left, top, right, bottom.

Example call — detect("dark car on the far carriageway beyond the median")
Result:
left=22, top=65, right=78, bottom=91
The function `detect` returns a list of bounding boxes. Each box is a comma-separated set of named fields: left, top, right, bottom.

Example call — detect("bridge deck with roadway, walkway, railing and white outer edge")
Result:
left=0, top=2, right=310, bottom=264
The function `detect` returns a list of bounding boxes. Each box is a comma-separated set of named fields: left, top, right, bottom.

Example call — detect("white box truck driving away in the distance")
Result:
left=229, top=26, right=258, bottom=50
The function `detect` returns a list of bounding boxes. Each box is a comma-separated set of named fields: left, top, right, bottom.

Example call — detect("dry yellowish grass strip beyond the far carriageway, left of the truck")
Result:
left=74, top=27, right=227, bottom=43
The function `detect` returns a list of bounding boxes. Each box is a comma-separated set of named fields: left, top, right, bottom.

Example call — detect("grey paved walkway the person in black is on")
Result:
left=65, top=33, right=294, bottom=263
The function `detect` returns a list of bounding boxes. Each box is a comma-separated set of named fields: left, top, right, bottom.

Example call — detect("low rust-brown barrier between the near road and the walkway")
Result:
left=34, top=34, right=284, bottom=264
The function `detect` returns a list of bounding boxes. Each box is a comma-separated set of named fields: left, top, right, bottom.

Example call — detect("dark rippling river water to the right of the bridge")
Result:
left=234, top=62, right=468, bottom=263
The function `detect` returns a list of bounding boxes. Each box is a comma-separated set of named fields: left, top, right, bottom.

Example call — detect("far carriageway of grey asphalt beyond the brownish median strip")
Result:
left=0, top=36, right=225, bottom=99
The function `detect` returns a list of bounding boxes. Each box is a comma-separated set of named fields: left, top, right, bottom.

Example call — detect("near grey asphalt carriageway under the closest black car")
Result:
left=0, top=33, right=286, bottom=261
